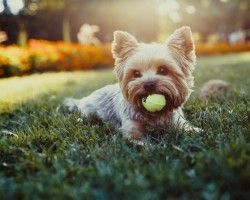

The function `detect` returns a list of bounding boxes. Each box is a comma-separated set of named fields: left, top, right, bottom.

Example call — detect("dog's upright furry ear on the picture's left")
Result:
left=112, top=31, right=138, bottom=59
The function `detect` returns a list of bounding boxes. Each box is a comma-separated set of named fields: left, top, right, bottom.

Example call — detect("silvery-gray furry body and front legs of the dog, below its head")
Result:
left=64, top=83, right=199, bottom=137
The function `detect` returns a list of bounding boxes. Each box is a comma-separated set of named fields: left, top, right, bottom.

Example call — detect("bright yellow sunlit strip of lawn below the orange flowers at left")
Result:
left=0, top=71, right=104, bottom=114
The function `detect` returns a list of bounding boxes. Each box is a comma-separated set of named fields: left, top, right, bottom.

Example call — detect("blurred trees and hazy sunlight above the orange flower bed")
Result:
left=0, top=0, right=250, bottom=44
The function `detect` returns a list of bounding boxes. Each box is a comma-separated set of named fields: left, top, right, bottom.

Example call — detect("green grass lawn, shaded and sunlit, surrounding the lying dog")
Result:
left=0, top=53, right=250, bottom=200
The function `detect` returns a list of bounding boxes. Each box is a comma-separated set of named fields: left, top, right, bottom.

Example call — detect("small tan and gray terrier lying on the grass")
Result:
left=64, top=27, right=201, bottom=142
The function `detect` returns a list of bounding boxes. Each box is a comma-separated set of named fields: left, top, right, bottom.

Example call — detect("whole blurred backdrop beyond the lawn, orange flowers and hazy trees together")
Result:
left=0, top=0, right=250, bottom=77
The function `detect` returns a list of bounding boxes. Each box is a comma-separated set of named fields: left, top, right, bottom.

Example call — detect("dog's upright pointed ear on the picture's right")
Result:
left=164, top=26, right=196, bottom=65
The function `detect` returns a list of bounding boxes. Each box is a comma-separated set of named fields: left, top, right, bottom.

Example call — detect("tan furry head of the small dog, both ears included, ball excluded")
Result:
left=112, top=27, right=196, bottom=112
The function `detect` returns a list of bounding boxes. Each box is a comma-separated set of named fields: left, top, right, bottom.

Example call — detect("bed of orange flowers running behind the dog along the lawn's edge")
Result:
left=0, top=40, right=250, bottom=77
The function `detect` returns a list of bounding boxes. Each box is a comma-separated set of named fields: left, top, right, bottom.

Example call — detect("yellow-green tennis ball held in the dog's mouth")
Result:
left=142, top=94, right=166, bottom=112
